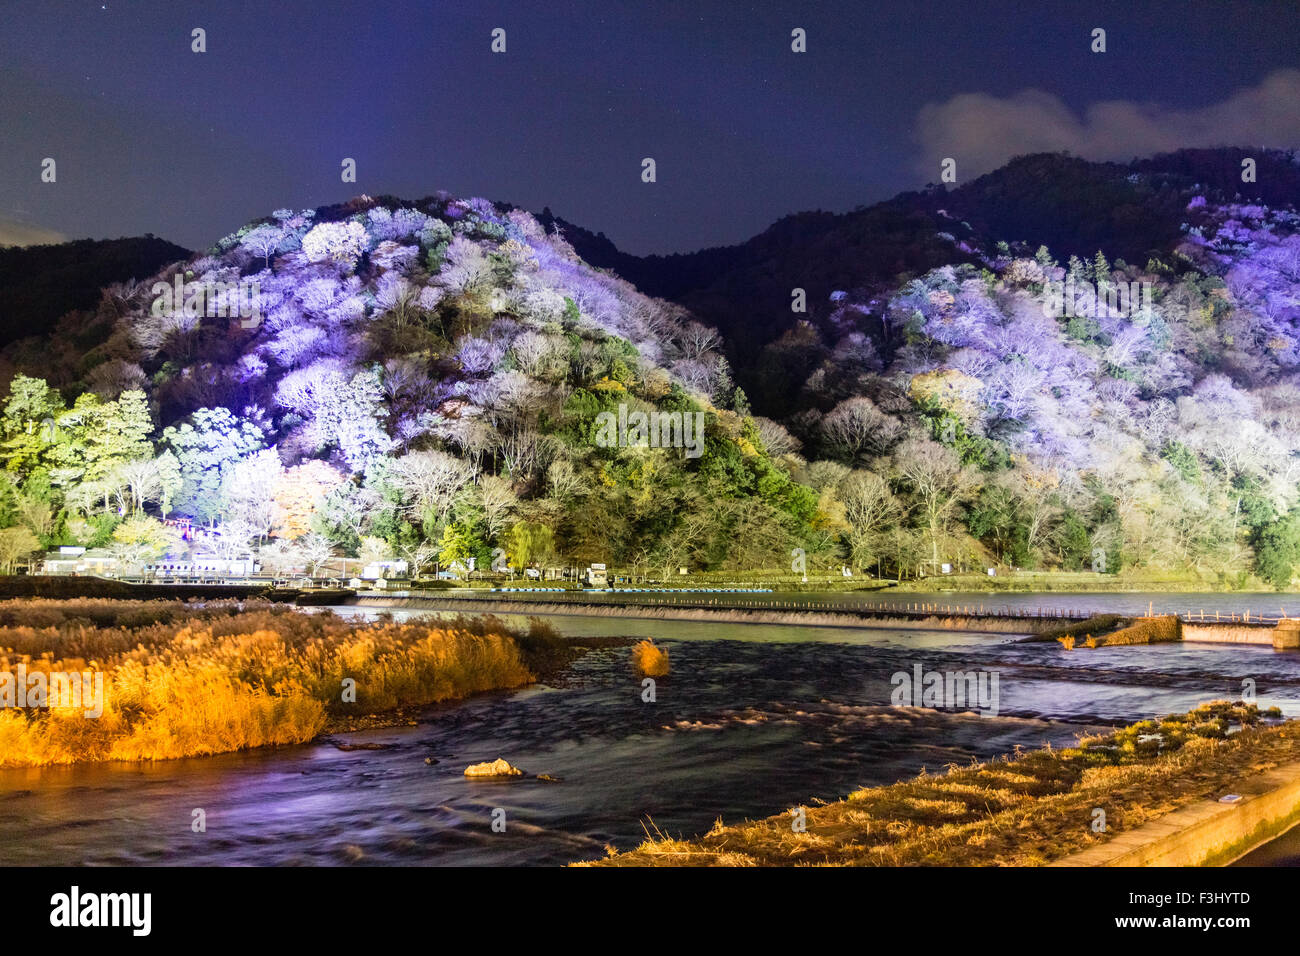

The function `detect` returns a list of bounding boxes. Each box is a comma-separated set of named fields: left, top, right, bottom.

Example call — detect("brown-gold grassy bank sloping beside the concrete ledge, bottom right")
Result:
left=579, top=701, right=1300, bottom=866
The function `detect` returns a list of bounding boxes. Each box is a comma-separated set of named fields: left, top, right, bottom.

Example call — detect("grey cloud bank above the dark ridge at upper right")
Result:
left=917, top=70, right=1300, bottom=182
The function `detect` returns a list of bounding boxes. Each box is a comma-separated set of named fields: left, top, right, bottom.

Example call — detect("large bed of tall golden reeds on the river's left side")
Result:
left=0, top=601, right=538, bottom=766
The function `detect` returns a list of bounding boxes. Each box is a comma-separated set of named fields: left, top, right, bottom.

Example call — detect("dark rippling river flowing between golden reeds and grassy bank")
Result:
left=0, top=594, right=1300, bottom=865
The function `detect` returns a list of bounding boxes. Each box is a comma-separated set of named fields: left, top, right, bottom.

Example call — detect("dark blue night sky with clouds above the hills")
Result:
left=0, top=0, right=1300, bottom=252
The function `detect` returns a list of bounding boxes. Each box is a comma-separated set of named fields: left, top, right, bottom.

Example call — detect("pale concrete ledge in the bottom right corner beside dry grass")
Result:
left=1049, top=762, right=1300, bottom=866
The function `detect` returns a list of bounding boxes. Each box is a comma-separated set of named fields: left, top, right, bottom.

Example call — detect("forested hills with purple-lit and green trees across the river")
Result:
left=0, top=151, right=1300, bottom=587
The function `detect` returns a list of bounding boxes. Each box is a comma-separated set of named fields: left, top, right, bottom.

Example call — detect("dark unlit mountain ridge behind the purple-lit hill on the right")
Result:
left=538, top=148, right=1300, bottom=405
